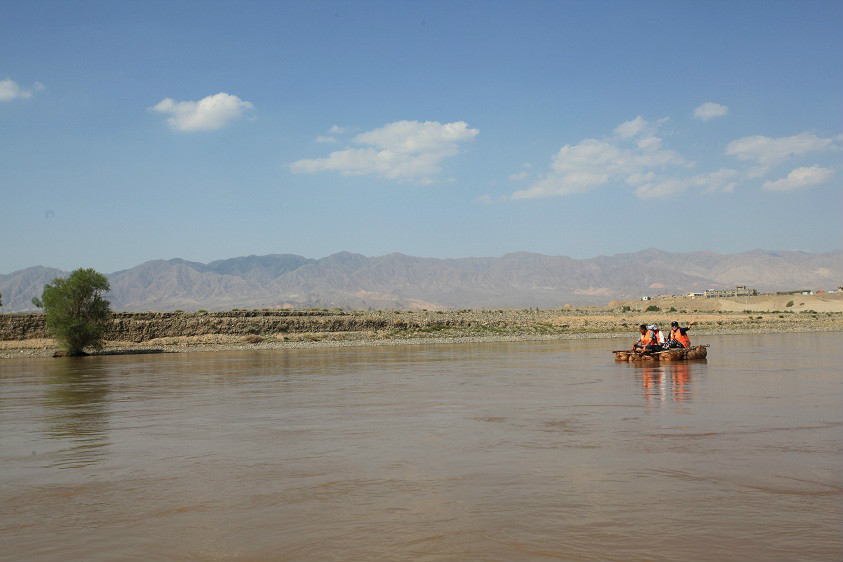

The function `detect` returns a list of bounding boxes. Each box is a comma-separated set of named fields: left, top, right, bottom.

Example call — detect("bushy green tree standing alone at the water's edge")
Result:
left=32, top=268, right=111, bottom=355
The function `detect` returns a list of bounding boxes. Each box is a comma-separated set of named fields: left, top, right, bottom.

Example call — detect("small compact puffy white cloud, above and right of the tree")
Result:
left=149, top=92, right=254, bottom=131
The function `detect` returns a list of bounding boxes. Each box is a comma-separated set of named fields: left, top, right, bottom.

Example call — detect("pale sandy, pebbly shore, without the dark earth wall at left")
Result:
left=0, top=295, right=843, bottom=358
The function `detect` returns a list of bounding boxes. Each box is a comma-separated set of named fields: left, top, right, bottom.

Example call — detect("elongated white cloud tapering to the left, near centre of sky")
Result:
left=290, top=121, right=479, bottom=183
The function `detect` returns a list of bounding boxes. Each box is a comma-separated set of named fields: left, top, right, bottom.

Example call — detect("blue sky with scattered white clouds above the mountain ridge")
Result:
left=0, top=0, right=843, bottom=273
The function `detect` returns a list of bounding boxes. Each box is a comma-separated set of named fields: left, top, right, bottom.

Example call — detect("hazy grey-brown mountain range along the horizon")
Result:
left=0, top=249, right=843, bottom=312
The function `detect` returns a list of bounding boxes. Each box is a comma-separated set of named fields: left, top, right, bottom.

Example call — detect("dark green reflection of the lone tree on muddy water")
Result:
left=42, top=358, right=109, bottom=468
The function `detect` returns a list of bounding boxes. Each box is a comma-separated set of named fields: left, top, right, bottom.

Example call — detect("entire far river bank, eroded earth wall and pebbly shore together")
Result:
left=0, top=295, right=843, bottom=358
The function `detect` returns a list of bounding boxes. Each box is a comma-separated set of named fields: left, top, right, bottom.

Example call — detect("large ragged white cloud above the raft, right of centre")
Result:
left=512, top=116, right=689, bottom=199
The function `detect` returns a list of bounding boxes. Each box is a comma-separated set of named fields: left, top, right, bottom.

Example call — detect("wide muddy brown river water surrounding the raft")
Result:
left=0, top=333, right=843, bottom=560
